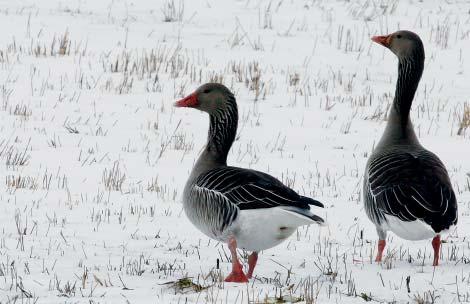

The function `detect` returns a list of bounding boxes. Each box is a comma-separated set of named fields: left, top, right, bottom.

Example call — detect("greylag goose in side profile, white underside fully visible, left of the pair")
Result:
left=175, top=83, right=324, bottom=283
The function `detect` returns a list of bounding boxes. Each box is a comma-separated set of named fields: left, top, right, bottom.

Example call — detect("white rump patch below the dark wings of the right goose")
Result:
left=382, top=215, right=436, bottom=241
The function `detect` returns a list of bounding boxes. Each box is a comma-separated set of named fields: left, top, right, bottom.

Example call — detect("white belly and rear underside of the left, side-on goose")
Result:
left=230, top=207, right=314, bottom=251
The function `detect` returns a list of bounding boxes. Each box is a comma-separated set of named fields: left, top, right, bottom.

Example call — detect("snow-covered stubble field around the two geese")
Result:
left=0, top=0, right=470, bottom=303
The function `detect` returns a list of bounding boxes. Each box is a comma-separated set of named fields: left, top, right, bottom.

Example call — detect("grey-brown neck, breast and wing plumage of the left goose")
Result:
left=178, top=84, right=323, bottom=248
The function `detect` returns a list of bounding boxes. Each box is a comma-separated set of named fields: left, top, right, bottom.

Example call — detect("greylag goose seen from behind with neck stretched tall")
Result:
left=364, top=31, right=457, bottom=266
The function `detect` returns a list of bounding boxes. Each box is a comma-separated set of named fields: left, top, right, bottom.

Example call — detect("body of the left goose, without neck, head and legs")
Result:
left=183, top=166, right=322, bottom=251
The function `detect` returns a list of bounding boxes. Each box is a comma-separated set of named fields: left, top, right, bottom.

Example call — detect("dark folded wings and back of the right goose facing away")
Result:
left=364, top=149, right=457, bottom=231
